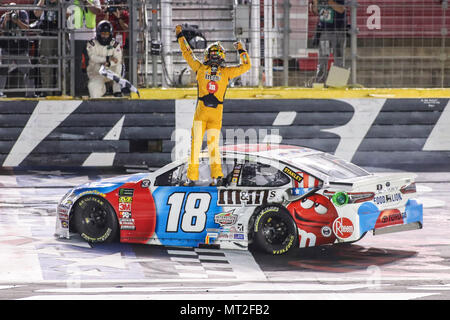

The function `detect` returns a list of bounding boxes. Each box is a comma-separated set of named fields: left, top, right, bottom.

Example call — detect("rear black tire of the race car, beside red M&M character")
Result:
left=253, top=205, right=298, bottom=255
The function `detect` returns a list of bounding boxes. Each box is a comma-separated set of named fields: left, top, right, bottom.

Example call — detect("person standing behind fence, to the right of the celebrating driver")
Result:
left=312, top=0, right=347, bottom=83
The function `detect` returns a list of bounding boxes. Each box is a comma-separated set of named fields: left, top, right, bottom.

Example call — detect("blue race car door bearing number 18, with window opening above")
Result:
left=153, top=158, right=233, bottom=247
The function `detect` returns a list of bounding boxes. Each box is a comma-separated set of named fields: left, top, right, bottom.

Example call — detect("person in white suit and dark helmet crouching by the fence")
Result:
left=86, top=20, right=122, bottom=98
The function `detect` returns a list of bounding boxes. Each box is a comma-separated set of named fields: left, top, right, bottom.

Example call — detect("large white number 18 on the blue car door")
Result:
left=166, top=192, right=211, bottom=232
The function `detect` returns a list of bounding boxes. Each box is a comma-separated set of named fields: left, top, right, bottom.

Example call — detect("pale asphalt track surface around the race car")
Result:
left=0, top=171, right=450, bottom=302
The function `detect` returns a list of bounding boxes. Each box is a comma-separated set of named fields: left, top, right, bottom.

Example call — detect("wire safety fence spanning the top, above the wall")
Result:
left=0, top=0, right=450, bottom=97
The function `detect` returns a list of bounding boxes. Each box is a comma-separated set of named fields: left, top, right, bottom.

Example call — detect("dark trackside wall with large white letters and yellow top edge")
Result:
left=0, top=88, right=450, bottom=171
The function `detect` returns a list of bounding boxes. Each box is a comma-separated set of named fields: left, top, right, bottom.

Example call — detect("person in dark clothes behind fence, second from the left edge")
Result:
left=34, top=0, right=59, bottom=96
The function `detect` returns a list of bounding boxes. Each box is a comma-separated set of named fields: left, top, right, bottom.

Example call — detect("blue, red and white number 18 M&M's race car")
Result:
left=56, top=144, right=423, bottom=255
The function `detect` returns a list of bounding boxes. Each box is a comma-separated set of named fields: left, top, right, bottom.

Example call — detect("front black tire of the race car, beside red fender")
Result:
left=71, top=196, right=119, bottom=243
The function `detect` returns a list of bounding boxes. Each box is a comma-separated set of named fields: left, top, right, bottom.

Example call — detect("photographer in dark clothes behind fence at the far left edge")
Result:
left=0, top=3, right=35, bottom=97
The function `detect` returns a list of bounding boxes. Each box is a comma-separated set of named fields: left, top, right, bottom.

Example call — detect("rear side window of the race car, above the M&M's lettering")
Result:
left=239, top=162, right=290, bottom=187
